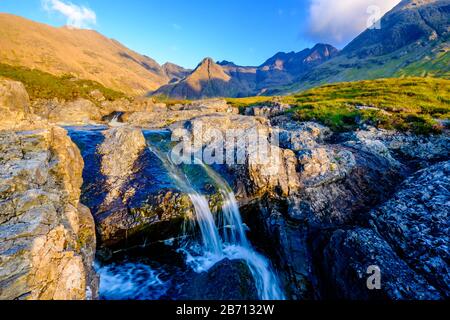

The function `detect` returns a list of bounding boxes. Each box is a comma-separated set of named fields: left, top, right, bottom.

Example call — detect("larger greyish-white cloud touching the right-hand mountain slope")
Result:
left=306, top=0, right=400, bottom=45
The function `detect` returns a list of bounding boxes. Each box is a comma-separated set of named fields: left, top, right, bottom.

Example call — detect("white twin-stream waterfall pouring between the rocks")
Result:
left=148, top=143, right=284, bottom=300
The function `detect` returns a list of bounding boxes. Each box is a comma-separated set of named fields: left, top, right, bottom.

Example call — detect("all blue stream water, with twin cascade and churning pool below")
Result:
left=67, top=127, right=285, bottom=300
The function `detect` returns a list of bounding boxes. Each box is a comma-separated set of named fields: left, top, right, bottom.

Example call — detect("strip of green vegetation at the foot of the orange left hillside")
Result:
left=0, top=63, right=125, bottom=101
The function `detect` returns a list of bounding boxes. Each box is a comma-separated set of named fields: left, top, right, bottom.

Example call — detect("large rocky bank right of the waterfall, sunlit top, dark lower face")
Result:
left=181, top=115, right=448, bottom=299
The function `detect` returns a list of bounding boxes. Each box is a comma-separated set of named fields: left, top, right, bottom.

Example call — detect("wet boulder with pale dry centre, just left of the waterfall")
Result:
left=71, top=126, right=198, bottom=247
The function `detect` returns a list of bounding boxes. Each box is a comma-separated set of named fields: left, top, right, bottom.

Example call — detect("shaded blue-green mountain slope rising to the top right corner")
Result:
left=276, top=0, right=450, bottom=94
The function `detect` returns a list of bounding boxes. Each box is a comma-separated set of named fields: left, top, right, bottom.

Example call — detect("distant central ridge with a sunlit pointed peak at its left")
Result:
left=151, top=44, right=338, bottom=99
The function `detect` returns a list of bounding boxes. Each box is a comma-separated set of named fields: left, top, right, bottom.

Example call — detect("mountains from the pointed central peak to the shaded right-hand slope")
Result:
left=153, top=0, right=450, bottom=99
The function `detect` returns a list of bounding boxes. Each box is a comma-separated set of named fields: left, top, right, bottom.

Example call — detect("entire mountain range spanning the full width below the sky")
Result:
left=0, top=0, right=450, bottom=99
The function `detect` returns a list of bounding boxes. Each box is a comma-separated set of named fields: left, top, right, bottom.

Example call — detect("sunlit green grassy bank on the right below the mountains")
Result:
left=234, top=78, right=450, bottom=134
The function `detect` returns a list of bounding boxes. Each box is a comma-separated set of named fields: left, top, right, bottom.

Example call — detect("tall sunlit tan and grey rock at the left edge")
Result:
left=0, top=127, right=97, bottom=300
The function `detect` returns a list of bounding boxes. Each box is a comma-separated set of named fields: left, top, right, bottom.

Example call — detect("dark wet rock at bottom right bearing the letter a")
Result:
left=323, top=228, right=442, bottom=300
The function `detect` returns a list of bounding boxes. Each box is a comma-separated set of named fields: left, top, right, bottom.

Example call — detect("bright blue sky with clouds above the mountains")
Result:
left=0, top=0, right=399, bottom=68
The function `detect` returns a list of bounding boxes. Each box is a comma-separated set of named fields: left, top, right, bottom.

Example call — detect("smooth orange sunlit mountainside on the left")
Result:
left=0, top=13, right=170, bottom=94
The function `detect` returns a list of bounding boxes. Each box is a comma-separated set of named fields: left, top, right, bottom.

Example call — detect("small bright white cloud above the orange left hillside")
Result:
left=42, top=0, right=97, bottom=28
